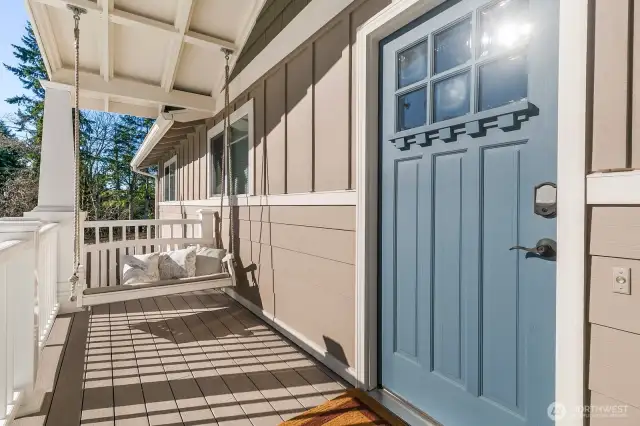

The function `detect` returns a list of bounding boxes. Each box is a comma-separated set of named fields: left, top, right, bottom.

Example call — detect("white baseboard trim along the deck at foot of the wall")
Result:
left=221, top=287, right=356, bottom=385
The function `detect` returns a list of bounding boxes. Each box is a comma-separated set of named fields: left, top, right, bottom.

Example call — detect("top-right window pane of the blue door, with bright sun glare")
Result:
left=478, top=0, right=533, bottom=57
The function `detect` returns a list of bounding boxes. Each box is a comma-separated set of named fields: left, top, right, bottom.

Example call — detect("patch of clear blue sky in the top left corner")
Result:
left=0, top=0, right=29, bottom=123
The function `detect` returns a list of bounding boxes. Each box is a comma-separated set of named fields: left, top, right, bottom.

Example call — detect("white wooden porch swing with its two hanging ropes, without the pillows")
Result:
left=68, top=5, right=236, bottom=308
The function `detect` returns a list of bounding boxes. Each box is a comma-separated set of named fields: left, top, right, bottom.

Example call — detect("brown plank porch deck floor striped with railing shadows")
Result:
left=14, top=290, right=344, bottom=426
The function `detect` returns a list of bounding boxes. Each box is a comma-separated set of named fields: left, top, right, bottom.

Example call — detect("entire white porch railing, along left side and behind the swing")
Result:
left=0, top=210, right=214, bottom=426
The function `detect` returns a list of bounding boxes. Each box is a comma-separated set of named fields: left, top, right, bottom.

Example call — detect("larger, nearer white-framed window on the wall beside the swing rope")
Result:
left=208, top=99, right=253, bottom=197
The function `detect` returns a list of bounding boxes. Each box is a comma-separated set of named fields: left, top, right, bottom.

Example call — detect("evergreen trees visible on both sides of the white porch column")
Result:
left=0, top=23, right=154, bottom=220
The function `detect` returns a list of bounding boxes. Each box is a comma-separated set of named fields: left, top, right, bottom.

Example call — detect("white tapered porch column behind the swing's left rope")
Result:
left=24, top=80, right=80, bottom=312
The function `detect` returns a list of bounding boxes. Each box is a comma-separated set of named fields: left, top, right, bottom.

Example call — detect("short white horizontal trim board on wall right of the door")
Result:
left=587, top=170, right=640, bottom=205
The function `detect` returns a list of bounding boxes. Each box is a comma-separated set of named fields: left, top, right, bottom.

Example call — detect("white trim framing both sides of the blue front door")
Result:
left=354, top=0, right=588, bottom=426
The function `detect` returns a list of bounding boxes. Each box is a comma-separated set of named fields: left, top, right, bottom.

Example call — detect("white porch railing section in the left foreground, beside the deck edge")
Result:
left=0, top=219, right=58, bottom=425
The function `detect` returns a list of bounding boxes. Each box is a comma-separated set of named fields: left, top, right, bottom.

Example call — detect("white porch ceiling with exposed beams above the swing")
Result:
left=25, top=0, right=265, bottom=121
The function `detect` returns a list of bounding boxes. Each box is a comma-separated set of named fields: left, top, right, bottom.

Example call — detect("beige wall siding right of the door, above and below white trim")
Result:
left=588, top=0, right=640, bottom=426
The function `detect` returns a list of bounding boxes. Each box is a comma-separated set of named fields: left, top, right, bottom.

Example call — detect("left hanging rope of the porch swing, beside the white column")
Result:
left=67, top=5, right=87, bottom=302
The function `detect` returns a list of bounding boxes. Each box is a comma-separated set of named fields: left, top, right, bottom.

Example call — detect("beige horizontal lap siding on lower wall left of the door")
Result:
left=155, top=205, right=355, bottom=366
